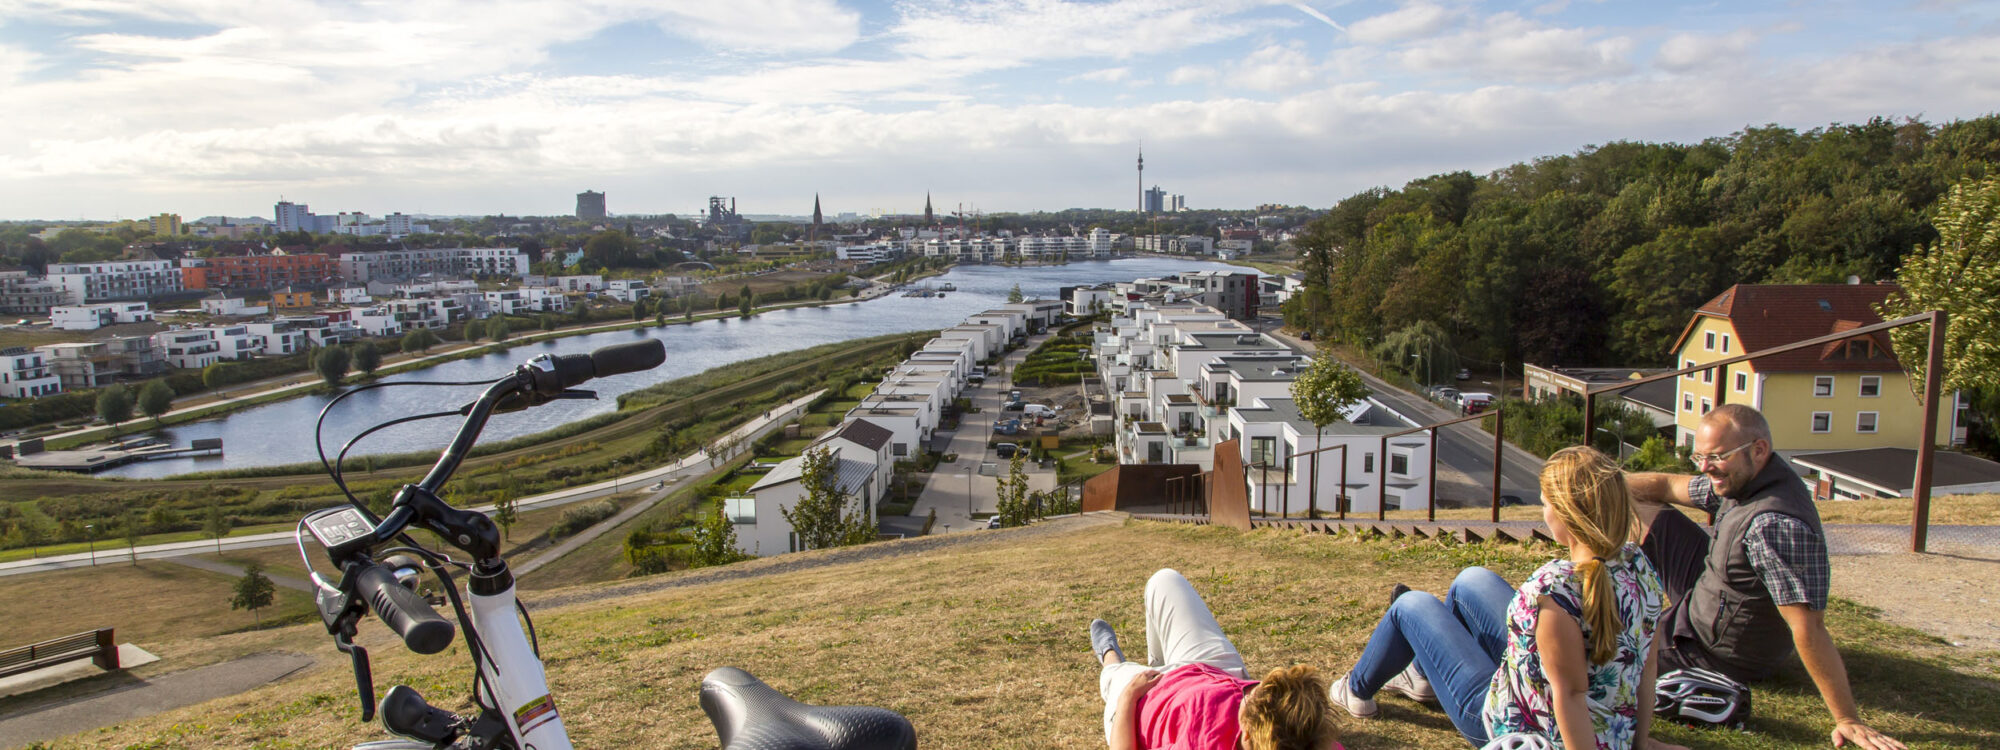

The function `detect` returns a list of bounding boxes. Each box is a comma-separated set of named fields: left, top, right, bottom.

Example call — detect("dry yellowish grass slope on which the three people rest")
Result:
left=39, top=516, right=2000, bottom=748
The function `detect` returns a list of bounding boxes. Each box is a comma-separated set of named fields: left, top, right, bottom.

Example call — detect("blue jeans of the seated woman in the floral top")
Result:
left=1348, top=568, right=1514, bottom=746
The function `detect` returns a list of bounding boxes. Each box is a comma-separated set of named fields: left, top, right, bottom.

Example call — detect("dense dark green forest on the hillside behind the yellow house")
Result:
left=1284, top=116, right=2000, bottom=366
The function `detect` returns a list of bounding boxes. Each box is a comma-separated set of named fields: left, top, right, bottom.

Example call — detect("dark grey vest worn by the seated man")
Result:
left=1688, top=456, right=1820, bottom=682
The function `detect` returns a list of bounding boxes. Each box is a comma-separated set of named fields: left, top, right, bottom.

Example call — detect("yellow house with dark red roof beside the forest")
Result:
left=1674, top=284, right=1966, bottom=452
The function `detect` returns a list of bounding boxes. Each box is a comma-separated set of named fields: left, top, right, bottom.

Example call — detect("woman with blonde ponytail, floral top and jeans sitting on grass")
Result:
left=1330, top=448, right=1674, bottom=750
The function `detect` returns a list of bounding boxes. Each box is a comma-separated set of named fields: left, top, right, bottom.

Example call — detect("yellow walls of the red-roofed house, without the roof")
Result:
left=1674, top=314, right=1954, bottom=450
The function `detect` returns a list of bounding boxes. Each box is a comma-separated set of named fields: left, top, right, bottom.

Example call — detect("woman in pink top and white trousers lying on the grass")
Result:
left=1090, top=570, right=1340, bottom=750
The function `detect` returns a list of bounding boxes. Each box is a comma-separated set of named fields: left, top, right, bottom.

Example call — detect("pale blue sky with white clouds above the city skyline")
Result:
left=0, top=0, right=2000, bottom=220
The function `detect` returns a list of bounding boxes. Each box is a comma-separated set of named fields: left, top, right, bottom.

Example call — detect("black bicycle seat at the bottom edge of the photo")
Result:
left=702, top=666, right=916, bottom=750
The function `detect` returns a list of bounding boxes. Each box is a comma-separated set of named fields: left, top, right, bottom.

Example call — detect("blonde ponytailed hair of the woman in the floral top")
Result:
left=1542, top=446, right=1638, bottom=664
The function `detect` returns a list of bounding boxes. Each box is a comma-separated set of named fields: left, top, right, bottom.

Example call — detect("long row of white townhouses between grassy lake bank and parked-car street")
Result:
left=724, top=300, right=1062, bottom=556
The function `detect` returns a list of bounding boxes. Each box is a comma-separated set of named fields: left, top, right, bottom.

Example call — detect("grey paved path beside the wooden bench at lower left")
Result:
left=0, top=652, right=314, bottom=748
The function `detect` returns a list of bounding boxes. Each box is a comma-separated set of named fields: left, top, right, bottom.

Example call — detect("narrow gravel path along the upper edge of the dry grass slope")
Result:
left=526, top=512, right=1126, bottom=608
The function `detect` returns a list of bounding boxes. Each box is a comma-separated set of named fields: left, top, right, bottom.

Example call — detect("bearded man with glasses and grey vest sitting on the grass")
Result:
left=1626, top=404, right=1902, bottom=750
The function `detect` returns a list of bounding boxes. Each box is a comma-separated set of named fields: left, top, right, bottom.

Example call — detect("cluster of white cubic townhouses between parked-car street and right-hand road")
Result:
left=1092, top=296, right=1432, bottom=514
